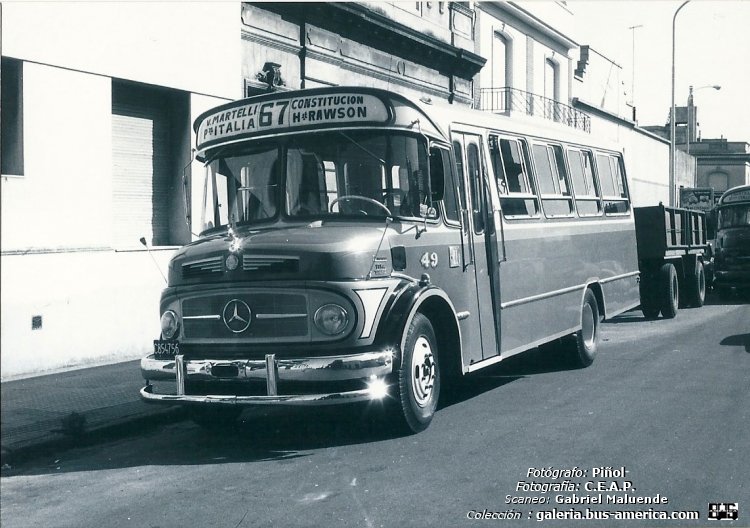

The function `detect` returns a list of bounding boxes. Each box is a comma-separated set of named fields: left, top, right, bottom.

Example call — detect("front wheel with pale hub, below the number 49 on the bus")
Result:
left=398, top=313, right=440, bottom=433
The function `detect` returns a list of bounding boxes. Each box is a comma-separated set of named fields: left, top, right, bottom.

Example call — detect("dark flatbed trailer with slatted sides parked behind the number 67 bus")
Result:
left=634, top=204, right=710, bottom=319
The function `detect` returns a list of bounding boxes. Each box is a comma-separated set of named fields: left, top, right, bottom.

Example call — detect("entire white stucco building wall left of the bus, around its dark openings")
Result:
left=0, top=2, right=242, bottom=380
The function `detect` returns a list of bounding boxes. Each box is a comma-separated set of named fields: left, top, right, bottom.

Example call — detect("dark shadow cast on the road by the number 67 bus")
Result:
left=4, top=345, right=588, bottom=476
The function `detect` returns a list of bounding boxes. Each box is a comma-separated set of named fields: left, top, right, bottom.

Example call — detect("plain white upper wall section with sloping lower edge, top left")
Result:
left=2, top=2, right=242, bottom=98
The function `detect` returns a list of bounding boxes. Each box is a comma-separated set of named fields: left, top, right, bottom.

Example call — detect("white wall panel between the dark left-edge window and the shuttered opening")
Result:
left=1, top=63, right=112, bottom=251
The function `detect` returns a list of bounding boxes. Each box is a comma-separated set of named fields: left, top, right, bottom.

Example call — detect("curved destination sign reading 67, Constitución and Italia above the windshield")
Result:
left=197, top=92, right=390, bottom=150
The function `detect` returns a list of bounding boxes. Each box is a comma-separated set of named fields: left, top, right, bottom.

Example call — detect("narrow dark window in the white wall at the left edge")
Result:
left=0, top=57, right=23, bottom=176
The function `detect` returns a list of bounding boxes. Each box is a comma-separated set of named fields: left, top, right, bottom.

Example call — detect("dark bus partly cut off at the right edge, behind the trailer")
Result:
left=714, top=185, right=750, bottom=297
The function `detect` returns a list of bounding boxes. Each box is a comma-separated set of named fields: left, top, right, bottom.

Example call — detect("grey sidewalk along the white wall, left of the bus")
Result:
left=0, top=361, right=183, bottom=465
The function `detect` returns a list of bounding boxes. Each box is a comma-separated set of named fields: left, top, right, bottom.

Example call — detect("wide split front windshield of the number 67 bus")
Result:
left=202, top=131, right=437, bottom=231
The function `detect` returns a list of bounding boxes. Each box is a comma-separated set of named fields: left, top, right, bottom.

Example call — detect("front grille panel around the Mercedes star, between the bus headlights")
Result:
left=182, top=292, right=310, bottom=341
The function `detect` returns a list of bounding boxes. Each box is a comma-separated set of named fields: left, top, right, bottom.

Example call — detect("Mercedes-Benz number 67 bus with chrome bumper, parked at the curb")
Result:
left=141, top=87, right=639, bottom=432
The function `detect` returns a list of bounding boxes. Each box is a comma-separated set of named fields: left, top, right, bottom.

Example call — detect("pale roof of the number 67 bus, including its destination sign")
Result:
left=193, top=86, right=621, bottom=154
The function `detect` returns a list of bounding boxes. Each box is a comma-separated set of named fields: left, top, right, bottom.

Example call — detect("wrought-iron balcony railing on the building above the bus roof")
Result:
left=479, top=87, right=591, bottom=133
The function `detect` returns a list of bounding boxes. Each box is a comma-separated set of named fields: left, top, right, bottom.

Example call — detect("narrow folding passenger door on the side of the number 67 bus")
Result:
left=453, top=133, right=500, bottom=359
